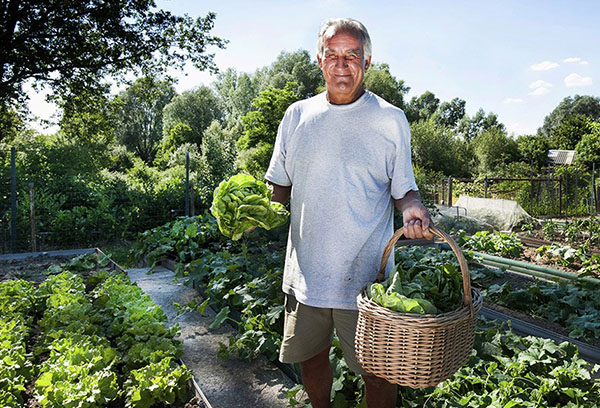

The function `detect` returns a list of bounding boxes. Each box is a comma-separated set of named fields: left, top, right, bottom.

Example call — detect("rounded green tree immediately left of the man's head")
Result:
left=263, top=50, right=324, bottom=99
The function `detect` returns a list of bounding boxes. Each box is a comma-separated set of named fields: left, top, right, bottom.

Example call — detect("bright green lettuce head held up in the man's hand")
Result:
left=210, top=174, right=289, bottom=241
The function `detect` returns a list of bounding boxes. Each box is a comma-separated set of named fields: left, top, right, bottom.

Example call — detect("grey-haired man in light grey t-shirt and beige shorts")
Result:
left=265, top=19, right=432, bottom=408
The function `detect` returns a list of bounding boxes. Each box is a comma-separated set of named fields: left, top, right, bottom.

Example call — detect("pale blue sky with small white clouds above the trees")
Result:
left=31, top=0, right=600, bottom=135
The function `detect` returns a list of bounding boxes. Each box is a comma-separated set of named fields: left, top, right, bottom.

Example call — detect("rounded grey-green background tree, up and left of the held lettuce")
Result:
left=163, top=86, right=223, bottom=146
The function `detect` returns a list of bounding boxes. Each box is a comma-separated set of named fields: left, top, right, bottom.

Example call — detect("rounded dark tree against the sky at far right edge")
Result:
left=538, top=95, right=600, bottom=138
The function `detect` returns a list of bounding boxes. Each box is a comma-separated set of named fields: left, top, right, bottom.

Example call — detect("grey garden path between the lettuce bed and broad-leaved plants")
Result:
left=127, top=267, right=295, bottom=408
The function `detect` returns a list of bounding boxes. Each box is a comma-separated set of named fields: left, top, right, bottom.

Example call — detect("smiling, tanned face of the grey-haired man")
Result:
left=317, top=32, right=371, bottom=105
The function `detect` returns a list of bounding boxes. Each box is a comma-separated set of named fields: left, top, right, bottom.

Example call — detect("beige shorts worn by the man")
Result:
left=279, top=294, right=370, bottom=375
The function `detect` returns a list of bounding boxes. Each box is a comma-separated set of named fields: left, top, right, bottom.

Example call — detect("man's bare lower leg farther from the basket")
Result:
left=300, top=347, right=333, bottom=408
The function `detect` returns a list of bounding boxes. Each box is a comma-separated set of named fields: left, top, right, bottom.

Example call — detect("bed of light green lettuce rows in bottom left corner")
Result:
left=0, top=250, right=207, bottom=408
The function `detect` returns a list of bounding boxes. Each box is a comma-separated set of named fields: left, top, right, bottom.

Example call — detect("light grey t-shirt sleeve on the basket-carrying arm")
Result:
left=391, top=112, right=418, bottom=200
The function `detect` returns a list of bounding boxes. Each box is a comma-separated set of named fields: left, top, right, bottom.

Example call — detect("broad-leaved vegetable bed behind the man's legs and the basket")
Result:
left=136, top=215, right=600, bottom=407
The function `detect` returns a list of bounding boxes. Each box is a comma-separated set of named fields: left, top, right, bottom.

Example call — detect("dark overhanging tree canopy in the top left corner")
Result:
left=0, top=0, right=225, bottom=105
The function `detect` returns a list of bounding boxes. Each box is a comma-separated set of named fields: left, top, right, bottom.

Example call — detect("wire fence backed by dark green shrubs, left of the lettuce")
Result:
left=0, top=149, right=200, bottom=253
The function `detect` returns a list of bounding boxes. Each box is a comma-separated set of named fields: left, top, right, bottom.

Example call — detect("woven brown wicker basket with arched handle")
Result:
left=355, top=227, right=483, bottom=388
